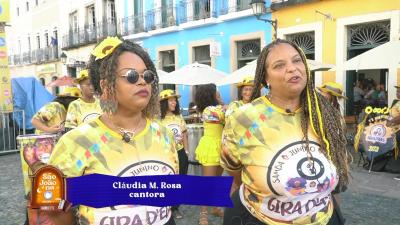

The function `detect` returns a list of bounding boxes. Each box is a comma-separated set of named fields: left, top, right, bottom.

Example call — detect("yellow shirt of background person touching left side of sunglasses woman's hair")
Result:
left=65, top=98, right=102, bottom=128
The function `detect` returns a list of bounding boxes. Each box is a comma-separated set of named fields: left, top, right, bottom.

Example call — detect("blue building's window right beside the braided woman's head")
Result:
left=236, top=39, right=261, bottom=69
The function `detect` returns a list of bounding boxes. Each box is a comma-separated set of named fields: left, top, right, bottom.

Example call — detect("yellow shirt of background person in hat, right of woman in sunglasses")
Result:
left=161, top=115, right=187, bottom=150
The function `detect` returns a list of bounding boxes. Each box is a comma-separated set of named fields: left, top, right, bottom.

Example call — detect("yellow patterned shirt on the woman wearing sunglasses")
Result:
left=49, top=119, right=179, bottom=225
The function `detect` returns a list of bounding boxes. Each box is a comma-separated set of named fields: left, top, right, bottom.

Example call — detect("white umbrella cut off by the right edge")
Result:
left=342, top=40, right=400, bottom=70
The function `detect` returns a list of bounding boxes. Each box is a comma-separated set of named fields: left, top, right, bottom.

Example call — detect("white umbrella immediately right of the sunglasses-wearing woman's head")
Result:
left=159, top=62, right=227, bottom=85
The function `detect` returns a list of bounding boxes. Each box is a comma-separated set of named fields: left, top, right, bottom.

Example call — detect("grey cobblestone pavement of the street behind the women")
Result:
left=0, top=154, right=400, bottom=225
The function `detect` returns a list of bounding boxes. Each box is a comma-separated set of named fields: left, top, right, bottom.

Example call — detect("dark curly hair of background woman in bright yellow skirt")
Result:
left=194, top=84, right=219, bottom=113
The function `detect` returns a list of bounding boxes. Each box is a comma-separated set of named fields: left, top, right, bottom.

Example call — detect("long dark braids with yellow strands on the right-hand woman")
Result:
left=252, top=39, right=351, bottom=190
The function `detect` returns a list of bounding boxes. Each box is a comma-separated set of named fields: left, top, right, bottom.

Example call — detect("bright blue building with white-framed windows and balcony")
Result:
left=119, top=0, right=272, bottom=107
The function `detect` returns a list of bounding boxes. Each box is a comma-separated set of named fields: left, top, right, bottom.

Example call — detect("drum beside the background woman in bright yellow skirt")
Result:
left=186, top=124, right=204, bottom=164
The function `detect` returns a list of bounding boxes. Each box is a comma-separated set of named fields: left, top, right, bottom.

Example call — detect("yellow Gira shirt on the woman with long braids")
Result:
left=221, top=97, right=338, bottom=225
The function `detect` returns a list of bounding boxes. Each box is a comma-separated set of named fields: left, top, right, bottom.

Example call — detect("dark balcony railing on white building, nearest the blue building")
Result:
left=62, top=19, right=117, bottom=49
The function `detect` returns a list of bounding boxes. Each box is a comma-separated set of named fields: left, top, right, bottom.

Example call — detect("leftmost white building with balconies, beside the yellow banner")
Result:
left=6, top=0, right=66, bottom=93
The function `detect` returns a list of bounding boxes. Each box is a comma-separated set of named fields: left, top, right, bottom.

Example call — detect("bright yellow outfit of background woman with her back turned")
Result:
left=196, top=105, right=225, bottom=166
